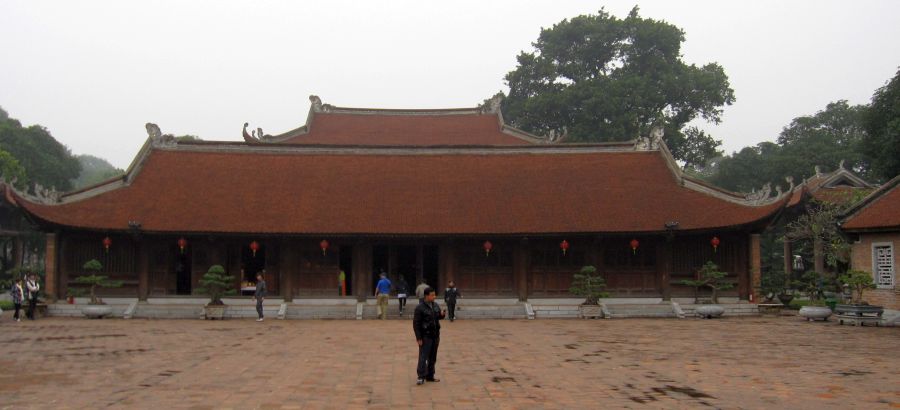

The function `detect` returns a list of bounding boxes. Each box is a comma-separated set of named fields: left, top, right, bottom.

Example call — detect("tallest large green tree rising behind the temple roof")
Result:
left=503, top=7, right=734, bottom=166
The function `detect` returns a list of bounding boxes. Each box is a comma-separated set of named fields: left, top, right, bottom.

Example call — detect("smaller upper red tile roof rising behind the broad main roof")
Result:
left=280, top=110, right=532, bottom=146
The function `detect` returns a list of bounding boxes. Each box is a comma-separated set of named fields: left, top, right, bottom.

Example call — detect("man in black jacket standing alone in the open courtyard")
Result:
left=413, top=287, right=447, bottom=385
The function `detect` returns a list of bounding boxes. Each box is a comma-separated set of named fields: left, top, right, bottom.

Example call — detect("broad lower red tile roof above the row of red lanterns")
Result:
left=16, top=145, right=784, bottom=234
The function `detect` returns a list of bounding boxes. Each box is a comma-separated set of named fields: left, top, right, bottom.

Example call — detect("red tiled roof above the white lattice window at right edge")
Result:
left=842, top=176, right=900, bottom=230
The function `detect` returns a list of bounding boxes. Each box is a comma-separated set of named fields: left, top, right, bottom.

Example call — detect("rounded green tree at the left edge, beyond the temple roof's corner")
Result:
left=0, top=105, right=81, bottom=191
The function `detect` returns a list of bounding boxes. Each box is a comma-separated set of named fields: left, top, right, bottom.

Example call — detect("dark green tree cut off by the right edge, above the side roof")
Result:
left=863, top=70, right=900, bottom=180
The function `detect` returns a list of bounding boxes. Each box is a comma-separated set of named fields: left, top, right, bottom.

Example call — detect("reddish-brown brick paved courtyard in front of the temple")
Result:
left=0, top=312, right=900, bottom=410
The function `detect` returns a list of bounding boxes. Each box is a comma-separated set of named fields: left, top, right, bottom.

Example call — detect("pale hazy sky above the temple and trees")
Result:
left=0, top=0, right=900, bottom=168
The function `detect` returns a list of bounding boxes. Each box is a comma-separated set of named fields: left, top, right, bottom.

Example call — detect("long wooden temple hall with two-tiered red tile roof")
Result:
left=3, top=97, right=791, bottom=300
